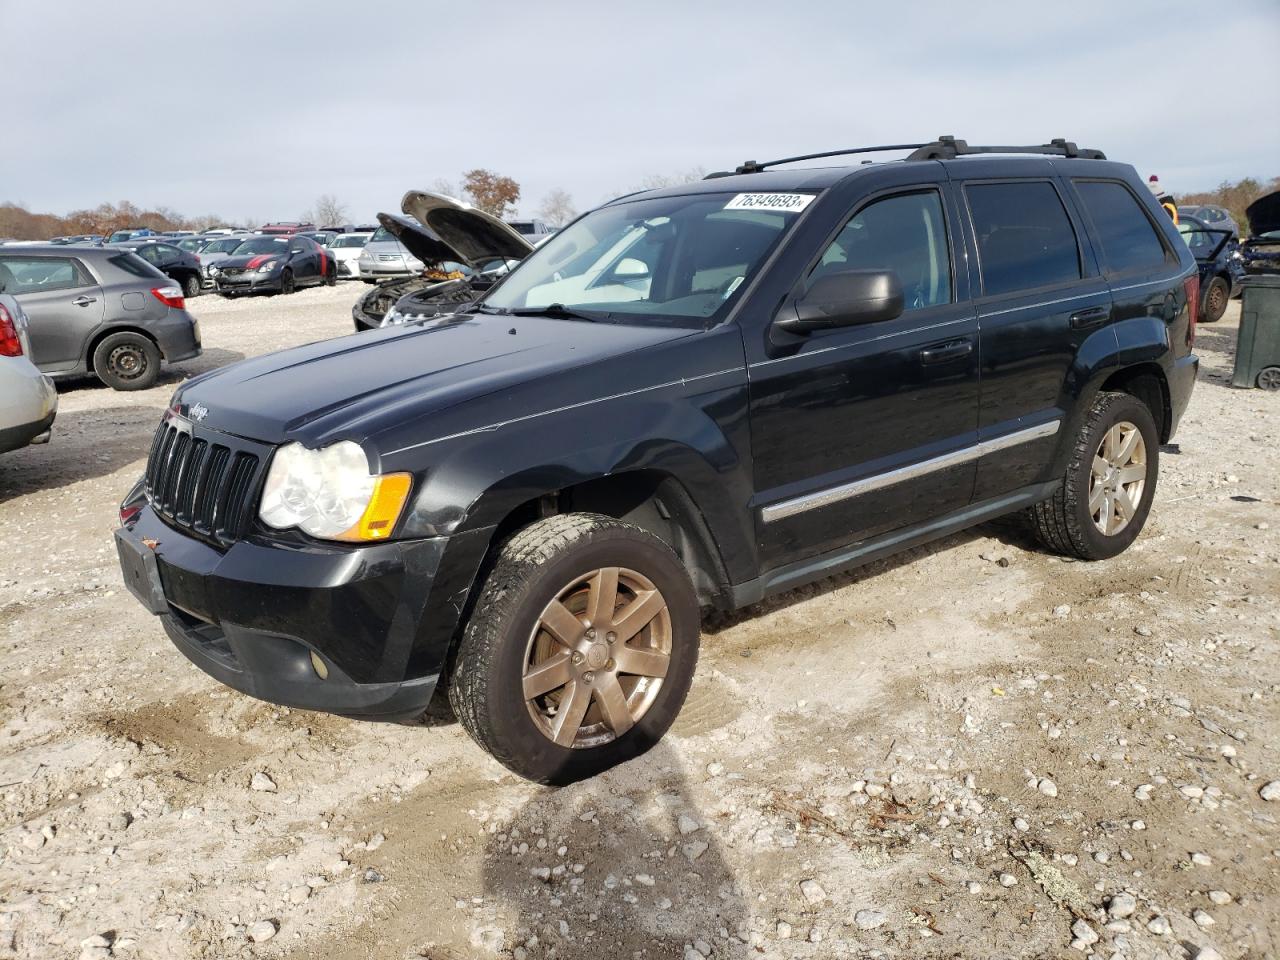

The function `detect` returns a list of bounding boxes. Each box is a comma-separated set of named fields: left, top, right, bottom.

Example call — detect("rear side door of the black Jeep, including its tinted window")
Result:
left=952, top=175, right=1115, bottom=502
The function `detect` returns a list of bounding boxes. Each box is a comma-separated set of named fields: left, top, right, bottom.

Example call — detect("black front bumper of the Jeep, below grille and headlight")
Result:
left=115, top=506, right=453, bottom=721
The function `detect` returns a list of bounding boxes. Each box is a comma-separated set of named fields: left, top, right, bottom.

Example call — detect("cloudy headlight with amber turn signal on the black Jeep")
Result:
left=259, top=440, right=412, bottom=543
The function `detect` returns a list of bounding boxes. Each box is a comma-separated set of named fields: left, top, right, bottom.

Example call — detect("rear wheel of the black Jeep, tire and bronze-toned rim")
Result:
left=1027, top=393, right=1160, bottom=561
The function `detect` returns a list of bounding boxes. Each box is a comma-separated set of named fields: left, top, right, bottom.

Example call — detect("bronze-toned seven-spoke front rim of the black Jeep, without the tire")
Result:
left=524, top=567, right=672, bottom=749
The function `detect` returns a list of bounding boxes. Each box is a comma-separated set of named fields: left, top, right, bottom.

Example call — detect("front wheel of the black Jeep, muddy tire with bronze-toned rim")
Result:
left=449, top=513, right=701, bottom=785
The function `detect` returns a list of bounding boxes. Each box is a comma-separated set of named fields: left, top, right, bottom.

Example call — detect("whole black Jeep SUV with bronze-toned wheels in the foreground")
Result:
left=115, top=138, right=1199, bottom=783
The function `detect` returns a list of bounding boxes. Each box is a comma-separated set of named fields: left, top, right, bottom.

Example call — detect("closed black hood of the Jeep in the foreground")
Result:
left=174, top=314, right=694, bottom=454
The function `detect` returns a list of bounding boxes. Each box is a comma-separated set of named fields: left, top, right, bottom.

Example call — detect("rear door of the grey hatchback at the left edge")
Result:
left=0, top=253, right=105, bottom=374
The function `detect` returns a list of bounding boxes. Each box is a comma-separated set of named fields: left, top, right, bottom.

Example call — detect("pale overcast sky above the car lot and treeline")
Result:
left=0, top=0, right=1280, bottom=220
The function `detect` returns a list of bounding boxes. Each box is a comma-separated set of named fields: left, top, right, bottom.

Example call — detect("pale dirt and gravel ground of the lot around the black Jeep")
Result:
left=0, top=285, right=1280, bottom=960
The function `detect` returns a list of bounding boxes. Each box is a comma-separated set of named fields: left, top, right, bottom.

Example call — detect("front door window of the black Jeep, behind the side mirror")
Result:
left=809, top=189, right=951, bottom=310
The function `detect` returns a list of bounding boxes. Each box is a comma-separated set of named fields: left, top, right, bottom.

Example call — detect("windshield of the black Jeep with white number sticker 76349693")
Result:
left=484, top=193, right=812, bottom=324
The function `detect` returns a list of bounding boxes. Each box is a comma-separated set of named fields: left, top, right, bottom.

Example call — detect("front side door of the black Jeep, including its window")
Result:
left=749, top=184, right=978, bottom=570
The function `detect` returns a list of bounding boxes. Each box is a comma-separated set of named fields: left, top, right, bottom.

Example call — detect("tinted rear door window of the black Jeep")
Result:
left=965, top=180, right=1082, bottom=297
